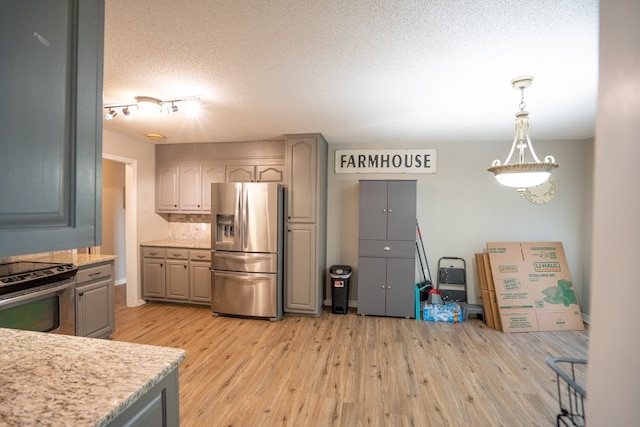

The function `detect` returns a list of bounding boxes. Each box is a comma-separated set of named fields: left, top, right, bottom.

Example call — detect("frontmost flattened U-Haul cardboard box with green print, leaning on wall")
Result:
left=485, top=242, right=584, bottom=332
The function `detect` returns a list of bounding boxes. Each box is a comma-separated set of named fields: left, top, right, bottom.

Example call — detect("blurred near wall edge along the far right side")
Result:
left=587, top=0, right=640, bottom=426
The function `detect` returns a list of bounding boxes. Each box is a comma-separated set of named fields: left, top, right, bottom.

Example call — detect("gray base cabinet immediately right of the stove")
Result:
left=76, top=260, right=115, bottom=338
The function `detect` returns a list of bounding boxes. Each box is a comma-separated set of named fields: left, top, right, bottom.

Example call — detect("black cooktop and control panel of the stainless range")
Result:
left=0, top=261, right=78, bottom=295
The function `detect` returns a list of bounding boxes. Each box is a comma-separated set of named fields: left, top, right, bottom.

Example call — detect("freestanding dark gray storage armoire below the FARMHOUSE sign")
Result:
left=358, top=180, right=417, bottom=318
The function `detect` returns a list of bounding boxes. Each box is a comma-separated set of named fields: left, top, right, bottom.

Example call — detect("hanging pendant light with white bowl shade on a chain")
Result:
left=487, top=76, right=560, bottom=192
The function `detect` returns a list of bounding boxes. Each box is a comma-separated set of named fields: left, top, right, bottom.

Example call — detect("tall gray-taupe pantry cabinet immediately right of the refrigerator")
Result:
left=284, top=134, right=327, bottom=316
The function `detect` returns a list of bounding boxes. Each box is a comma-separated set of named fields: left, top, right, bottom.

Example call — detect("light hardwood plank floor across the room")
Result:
left=112, top=286, right=588, bottom=427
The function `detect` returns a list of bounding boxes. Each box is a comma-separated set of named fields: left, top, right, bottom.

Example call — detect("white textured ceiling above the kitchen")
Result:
left=104, top=0, right=599, bottom=144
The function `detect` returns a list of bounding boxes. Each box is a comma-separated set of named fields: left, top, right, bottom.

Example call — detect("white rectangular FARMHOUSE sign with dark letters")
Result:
left=335, top=149, right=436, bottom=173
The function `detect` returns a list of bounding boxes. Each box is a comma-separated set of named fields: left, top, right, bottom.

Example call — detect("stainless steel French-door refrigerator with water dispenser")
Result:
left=211, top=182, right=285, bottom=320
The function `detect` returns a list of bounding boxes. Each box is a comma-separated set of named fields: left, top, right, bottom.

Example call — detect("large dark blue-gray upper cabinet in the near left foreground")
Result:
left=0, top=0, right=104, bottom=256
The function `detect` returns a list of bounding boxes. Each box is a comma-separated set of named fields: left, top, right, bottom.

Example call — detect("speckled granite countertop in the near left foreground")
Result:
left=0, top=328, right=185, bottom=427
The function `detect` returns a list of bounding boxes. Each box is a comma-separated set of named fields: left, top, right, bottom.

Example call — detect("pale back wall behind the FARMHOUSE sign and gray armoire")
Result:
left=325, top=140, right=593, bottom=313
